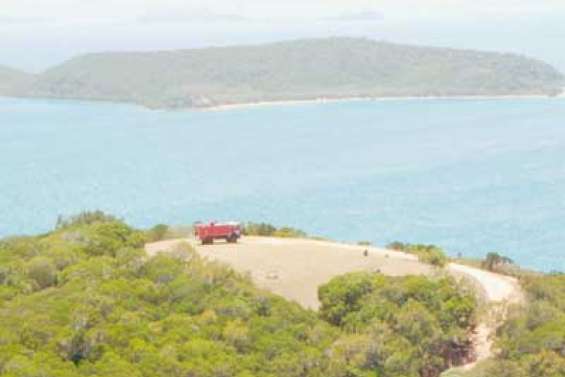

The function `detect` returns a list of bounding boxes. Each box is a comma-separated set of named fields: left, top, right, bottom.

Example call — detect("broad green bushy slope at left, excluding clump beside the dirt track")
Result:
left=0, top=217, right=337, bottom=377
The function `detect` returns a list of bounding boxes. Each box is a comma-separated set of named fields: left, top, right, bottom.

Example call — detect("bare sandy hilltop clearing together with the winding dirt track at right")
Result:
left=146, top=237, right=524, bottom=369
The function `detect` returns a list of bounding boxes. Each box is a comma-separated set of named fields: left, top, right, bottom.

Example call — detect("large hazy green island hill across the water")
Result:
left=13, top=38, right=565, bottom=108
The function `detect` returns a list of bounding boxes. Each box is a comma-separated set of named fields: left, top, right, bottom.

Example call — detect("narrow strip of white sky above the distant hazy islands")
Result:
left=0, top=0, right=565, bottom=21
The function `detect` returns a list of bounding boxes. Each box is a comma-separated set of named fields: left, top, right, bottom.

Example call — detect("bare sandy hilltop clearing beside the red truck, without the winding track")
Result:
left=146, top=237, right=433, bottom=309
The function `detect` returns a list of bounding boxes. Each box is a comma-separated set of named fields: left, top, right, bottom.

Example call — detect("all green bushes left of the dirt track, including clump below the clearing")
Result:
left=0, top=213, right=480, bottom=377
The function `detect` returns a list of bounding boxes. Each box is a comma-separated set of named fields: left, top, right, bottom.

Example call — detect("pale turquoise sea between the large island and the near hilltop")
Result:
left=0, top=99, right=565, bottom=271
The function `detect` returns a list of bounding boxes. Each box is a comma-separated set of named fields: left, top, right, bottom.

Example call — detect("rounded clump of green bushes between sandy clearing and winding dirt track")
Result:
left=319, top=273, right=476, bottom=377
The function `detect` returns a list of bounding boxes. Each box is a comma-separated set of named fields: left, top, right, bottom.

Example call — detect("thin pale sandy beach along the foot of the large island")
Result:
left=200, top=91, right=565, bottom=111
